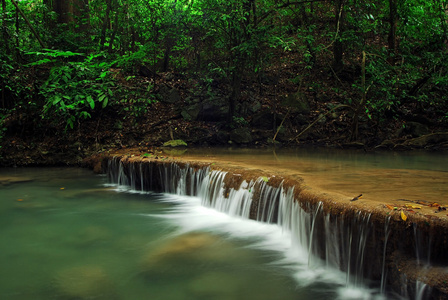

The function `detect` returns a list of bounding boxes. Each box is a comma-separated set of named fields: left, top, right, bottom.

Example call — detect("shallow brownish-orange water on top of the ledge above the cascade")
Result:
left=178, top=148, right=448, bottom=205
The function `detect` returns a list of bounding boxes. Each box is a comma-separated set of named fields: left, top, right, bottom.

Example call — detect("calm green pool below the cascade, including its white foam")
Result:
left=0, top=168, right=375, bottom=300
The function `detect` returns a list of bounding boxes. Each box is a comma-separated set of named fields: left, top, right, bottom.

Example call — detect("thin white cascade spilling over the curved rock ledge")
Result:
left=107, top=157, right=448, bottom=299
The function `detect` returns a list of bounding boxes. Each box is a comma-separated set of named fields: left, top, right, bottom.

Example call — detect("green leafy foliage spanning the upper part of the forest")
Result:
left=0, top=0, right=448, bottom=139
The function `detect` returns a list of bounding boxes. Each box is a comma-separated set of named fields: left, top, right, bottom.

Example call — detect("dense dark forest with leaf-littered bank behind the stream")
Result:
left=0, top=0, right=448, bottom=165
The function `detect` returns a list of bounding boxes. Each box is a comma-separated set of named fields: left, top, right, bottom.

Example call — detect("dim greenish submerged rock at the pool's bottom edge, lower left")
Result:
left=54, top=266, right=118, bottom=300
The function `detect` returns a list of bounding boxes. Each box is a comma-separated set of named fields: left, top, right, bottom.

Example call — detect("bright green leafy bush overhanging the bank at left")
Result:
left=28, top=50, right=115, bottom=129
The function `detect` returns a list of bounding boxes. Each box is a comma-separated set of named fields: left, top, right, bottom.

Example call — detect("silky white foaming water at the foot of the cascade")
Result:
left=145, top=195, right=383, bottom=299
